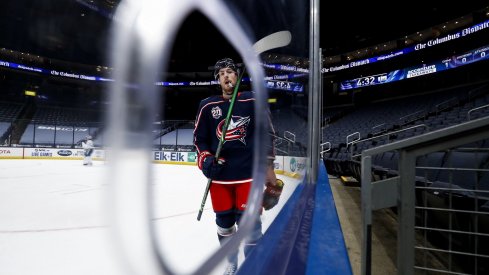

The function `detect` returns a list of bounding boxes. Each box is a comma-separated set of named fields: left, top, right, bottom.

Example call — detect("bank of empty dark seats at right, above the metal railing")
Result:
left=322, top=85, right=489, bottom=160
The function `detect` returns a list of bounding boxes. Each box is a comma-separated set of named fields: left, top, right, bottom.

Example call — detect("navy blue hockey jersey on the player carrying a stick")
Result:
left=194, top=92, right=272, bottom=184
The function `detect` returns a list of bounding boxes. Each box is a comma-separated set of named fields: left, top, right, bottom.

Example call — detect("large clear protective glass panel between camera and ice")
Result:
left=0, top=0, right=310, bottom=274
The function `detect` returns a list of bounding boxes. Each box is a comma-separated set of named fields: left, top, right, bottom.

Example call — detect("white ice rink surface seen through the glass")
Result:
left=0, top=160, right=300, bottom=275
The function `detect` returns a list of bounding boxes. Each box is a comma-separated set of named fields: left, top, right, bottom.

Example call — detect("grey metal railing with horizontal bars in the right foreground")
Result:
left=361, top=117, right=489, bottom=275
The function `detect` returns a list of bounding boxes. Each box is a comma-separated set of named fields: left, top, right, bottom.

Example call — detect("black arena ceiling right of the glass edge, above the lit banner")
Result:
left=320, top=0, right=489, bottom=56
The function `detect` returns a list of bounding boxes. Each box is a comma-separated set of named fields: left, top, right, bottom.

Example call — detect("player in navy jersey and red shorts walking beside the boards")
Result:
left=194, top=58, right=283, bottom=274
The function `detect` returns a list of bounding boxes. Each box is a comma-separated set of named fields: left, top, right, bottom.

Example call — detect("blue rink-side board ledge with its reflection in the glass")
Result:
left=237, top=161, right=353, bottom=275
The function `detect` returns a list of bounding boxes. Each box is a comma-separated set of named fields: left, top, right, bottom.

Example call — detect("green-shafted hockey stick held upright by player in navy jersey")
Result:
left=197, top=31, right=292, bottom=221
